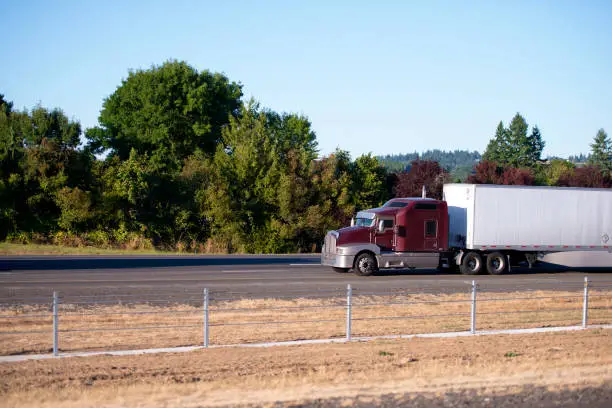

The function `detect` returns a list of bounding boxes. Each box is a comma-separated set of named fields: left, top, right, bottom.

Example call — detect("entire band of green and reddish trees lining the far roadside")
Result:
left=0, top=61, right=612, bottom=253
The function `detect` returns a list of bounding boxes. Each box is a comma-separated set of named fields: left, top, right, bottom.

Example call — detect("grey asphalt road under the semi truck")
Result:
left=0, top=253, right=612, bottom=302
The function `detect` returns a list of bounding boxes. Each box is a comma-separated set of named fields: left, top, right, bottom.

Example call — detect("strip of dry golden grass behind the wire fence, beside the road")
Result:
left=0, top=291, right=612, bottom=355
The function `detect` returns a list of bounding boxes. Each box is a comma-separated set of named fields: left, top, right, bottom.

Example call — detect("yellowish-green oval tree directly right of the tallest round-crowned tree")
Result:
left=204, top=101, right=278, bottom=250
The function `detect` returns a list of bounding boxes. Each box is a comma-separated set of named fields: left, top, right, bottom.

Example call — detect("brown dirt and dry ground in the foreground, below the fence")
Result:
left=0, top=329, right=612, bottom=408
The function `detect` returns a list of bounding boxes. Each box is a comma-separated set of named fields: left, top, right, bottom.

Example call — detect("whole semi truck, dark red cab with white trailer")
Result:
left=321, top=184, right=612, bottom=276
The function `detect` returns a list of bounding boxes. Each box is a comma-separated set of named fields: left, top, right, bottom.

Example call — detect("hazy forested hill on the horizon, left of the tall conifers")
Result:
left=378, top=149, right=481, bottom=180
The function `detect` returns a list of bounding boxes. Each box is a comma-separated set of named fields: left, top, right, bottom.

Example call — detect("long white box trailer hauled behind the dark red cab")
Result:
left=443, top=184, right=612, bottom=273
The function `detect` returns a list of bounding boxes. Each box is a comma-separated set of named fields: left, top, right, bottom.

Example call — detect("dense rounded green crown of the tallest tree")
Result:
left=87, top=61, right=242, bottom=170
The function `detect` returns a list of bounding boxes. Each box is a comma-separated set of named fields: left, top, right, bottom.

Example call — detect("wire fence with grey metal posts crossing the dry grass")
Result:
left=0, top=278, right=612, bottom=355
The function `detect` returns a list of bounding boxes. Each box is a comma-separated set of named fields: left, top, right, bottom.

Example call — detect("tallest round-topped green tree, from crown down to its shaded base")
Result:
left=86, top=61, right=242, bottom=246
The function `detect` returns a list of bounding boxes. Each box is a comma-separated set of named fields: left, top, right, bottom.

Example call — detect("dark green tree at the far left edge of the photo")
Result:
left=0, top=104, right=93, bottom=233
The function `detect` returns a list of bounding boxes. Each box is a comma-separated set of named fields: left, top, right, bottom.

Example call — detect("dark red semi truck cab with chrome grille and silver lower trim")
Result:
left=321, top=198, right=449, bottom=276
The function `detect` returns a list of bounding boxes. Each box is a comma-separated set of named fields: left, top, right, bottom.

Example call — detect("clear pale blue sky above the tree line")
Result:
left=0, top=0, right=612, bottom=157
